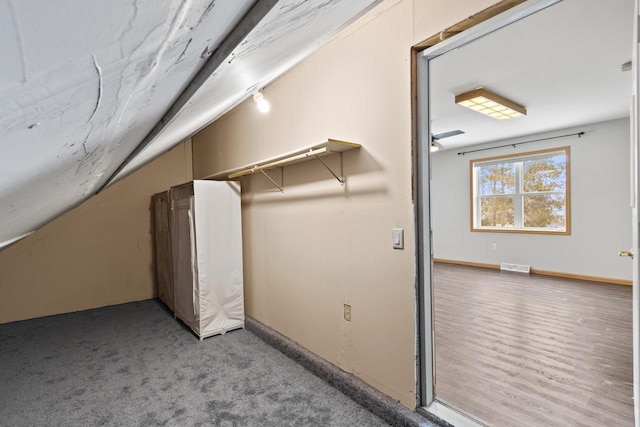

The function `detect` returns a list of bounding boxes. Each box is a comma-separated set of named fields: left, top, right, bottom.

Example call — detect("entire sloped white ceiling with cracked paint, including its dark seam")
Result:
left=0, top=0, right=379, bottom=247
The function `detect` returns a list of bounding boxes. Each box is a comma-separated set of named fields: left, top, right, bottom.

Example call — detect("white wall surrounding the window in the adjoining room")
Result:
left=431, top=119, right=631, bottom=280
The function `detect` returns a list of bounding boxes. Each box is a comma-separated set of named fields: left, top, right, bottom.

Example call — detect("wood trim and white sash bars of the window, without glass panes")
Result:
left=469, top=146, right=571, bottom=236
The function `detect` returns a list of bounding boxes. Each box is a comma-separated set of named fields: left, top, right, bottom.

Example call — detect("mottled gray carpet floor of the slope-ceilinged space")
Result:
left=0, top=300, right=387, bottom=426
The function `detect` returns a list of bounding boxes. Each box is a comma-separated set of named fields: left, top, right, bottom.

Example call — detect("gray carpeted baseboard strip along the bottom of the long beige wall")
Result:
left=245, top=316, right=449, bottom=427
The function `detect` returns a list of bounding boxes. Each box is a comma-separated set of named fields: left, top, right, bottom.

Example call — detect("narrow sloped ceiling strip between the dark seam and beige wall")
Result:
left=118, top=0, right=380, bottom=181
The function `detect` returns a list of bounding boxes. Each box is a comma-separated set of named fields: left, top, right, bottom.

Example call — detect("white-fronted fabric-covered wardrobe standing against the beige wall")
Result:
left=172, top=181, right=244, bottom=338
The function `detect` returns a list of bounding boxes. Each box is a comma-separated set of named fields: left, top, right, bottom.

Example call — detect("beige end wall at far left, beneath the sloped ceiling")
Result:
left=0, top=142, right=192, bottom=323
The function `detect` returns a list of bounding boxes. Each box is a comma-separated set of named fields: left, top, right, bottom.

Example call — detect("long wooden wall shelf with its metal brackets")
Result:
left=206, top=139, right=360, bottom=190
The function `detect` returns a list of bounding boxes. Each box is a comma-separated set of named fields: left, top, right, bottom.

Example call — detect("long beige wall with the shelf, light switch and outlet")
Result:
left=193, top=0, right=495, bottom=408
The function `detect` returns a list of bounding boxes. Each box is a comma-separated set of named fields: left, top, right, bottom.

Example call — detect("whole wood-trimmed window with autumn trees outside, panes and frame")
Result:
left=471, top=147, right=571, bottom=234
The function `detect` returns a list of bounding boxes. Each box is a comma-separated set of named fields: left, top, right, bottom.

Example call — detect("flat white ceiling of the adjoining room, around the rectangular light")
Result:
left=430, top=0, right=634, bottom=149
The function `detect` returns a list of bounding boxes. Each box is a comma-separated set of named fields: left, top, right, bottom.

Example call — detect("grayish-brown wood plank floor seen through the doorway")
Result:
left=433, top=263, right=633, bottom=427
